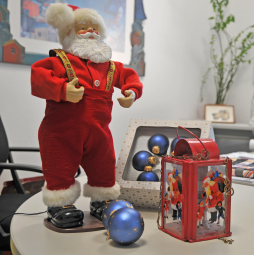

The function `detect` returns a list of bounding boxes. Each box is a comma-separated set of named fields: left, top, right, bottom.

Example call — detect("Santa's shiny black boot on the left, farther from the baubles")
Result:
left=48, top=205, right=84, bottom=228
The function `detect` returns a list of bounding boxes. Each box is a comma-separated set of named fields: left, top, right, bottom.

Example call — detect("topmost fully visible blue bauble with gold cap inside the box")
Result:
left=147, top=134, right=169, bottom=156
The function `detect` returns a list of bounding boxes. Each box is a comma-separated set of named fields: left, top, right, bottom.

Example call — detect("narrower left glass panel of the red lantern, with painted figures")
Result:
left=162, top=162, right=184, bottom=237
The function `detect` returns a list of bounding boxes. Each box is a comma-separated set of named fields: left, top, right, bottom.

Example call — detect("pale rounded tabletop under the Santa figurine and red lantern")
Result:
left=11, top=177, right=254, bottom=255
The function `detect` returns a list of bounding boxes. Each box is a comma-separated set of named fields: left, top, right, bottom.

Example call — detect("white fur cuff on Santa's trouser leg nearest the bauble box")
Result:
left=83, top=182, right=121, bottom=202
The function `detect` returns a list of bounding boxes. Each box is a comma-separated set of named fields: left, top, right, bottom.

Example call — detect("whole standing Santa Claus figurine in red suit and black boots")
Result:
left=31, top=3, right=142, bottom=228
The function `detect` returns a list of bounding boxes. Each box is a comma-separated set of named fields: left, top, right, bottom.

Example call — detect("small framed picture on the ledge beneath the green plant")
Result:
left=205, top=104, right=235, bottom=123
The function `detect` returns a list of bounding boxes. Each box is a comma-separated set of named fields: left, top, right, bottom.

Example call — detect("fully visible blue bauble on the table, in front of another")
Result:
left=108, top=208, right=144, bottom=244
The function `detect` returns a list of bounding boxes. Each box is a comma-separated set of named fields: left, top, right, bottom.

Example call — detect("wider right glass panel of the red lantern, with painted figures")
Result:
left=196, top=165, right=226, bottom=239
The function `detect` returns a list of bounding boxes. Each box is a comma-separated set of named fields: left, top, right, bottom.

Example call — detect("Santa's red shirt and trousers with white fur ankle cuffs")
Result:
left=31, top=54, right=142, bottom=206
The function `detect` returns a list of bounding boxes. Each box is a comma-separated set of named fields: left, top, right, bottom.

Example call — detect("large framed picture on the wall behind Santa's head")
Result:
left=0, top=0, right=135, bottom=65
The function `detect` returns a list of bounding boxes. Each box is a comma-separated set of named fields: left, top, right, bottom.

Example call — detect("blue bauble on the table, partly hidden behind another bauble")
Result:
left=102, top=200, right=133, bottom=228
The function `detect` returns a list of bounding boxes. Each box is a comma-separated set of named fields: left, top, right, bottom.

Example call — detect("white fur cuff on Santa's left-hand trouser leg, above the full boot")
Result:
left=42, top=180, right=81, bottom=207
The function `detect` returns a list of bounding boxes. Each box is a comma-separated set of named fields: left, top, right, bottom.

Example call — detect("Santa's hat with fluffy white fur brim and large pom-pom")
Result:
left=46, top=3, right=106, bottom=43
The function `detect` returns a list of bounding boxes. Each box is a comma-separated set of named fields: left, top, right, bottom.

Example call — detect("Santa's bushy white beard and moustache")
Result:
left=62, top=31, right=112, bottom=63
